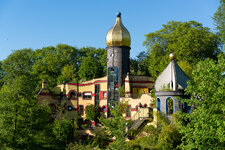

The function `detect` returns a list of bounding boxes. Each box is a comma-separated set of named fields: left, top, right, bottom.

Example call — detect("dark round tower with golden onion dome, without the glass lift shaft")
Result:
left=106, top=12, right=131, bottom=87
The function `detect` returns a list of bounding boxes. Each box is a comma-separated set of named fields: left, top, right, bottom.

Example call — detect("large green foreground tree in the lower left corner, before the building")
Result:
left=0, top=76, right=49, bottom=149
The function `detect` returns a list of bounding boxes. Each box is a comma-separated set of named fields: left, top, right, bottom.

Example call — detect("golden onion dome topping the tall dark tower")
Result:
left=106, top=12, right=131, bottom=47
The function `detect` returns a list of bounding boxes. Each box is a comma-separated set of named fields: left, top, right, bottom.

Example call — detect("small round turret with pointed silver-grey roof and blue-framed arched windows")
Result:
left=155, top=53, right=189, bottom=117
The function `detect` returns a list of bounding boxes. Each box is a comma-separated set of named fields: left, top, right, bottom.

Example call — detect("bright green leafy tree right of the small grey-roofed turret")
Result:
left=181, top=54, right=225, bottom=149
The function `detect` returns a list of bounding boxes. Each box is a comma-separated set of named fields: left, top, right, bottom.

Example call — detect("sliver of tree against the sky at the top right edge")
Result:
left=213, top=0, right=225, bottom=50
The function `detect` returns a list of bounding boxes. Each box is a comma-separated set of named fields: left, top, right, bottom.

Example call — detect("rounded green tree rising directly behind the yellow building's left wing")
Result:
left=32, top=44, right=79, bottom=87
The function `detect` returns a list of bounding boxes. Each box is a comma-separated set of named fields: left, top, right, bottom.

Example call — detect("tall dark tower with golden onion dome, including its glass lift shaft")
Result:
left=106, top=12, right=131, bottom=117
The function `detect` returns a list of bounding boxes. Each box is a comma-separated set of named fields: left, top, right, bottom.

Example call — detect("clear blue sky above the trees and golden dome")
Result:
left=0, top=0, right=219, bottom=60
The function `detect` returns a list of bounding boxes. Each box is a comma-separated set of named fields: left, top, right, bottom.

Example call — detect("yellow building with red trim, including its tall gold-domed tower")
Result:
left=37, top=13, right=154, bottom=123
